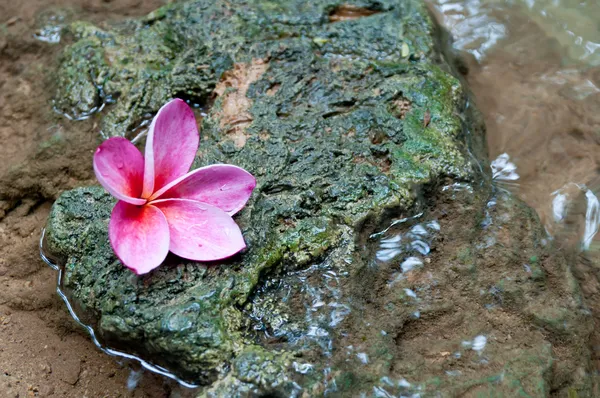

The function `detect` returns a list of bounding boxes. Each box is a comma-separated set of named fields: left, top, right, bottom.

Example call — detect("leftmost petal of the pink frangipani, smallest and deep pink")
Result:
left=93, top=137, right=146, bottom=205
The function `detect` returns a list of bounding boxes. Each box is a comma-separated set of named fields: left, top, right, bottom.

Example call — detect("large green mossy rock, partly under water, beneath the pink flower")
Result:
left=46, top=0, right=592, bottom=396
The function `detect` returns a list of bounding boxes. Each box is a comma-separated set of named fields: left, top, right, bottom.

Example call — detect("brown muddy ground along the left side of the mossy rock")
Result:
left=0, top=0, right=195, bottom=397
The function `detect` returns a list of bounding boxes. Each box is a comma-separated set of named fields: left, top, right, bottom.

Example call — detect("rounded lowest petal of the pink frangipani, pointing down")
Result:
left=108, top=201, right=169, bottom=275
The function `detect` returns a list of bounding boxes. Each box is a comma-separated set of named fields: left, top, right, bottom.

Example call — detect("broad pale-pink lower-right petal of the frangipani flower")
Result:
left=152, top=199, right=246, bottom=261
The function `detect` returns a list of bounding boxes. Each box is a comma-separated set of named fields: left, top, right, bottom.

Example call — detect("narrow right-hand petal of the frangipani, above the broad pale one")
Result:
left=150, top=164, right=256, bottom=215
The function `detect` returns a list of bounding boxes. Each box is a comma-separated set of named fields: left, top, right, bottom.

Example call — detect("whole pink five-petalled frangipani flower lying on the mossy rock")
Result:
left=94, top=99, right=256, bottom=275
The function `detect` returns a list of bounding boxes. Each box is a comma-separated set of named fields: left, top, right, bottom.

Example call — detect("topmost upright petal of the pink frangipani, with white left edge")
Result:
left=142, top=99, right=200, bottom=198
